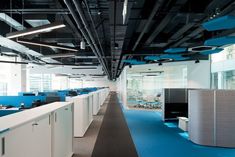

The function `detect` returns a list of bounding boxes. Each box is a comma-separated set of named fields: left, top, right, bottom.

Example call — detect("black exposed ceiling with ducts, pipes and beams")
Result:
left=0, top=0, right=235, bottom=79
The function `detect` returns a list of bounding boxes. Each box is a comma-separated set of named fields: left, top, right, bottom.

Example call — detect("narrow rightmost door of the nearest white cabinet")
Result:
left=52, top=105, right=73, bottom=157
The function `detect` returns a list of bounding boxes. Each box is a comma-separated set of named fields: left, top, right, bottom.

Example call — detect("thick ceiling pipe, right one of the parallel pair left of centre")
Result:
left=72, top=0, right=111, bottom=79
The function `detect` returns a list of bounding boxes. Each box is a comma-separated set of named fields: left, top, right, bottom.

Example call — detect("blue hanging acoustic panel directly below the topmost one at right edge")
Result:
left=204, top=36, right=235, bottom=46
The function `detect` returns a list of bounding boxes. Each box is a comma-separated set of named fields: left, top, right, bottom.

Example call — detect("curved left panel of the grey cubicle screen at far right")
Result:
left=189, top=90, right=215, bottom=146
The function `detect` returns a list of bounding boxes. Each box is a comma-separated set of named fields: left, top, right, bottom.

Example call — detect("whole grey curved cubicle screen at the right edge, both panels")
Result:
left=189, top=90, right=235, bottom=147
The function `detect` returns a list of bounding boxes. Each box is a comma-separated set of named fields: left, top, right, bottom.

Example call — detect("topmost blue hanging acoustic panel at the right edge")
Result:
left=202, top=15, right=235, bottom=31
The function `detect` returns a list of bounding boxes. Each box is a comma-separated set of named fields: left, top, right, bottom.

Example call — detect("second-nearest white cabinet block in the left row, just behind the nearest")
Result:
left=66, top=94, right=93, bottom=137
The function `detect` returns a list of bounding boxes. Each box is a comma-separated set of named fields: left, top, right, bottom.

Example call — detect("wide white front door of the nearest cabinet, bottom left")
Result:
left=2, top=115, right=51, bottom=157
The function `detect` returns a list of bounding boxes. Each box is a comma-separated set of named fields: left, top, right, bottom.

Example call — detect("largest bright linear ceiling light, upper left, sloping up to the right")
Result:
left=6, top=22, right=65, bottom=39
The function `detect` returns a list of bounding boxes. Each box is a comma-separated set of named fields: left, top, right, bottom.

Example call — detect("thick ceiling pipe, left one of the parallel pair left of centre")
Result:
left=64, top=0, right=110, bottom=78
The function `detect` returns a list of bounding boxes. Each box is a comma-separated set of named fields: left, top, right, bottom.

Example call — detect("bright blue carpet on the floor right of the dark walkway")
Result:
left=123, top=109, right=235, bottom=157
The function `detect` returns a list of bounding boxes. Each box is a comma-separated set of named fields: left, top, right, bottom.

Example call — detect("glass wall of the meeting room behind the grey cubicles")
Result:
left=127, top=65, right=187, bottom=110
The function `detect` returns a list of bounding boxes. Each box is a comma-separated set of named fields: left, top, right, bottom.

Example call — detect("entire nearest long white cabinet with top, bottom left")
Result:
left=0, top=102, right=73, bottom=157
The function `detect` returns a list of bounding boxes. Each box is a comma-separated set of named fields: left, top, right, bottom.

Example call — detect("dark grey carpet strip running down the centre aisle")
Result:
left=92, top=93, right=138, bottom=157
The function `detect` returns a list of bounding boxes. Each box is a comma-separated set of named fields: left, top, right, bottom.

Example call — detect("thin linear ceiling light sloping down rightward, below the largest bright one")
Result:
left=16, top=39, right=78, bottom=52
